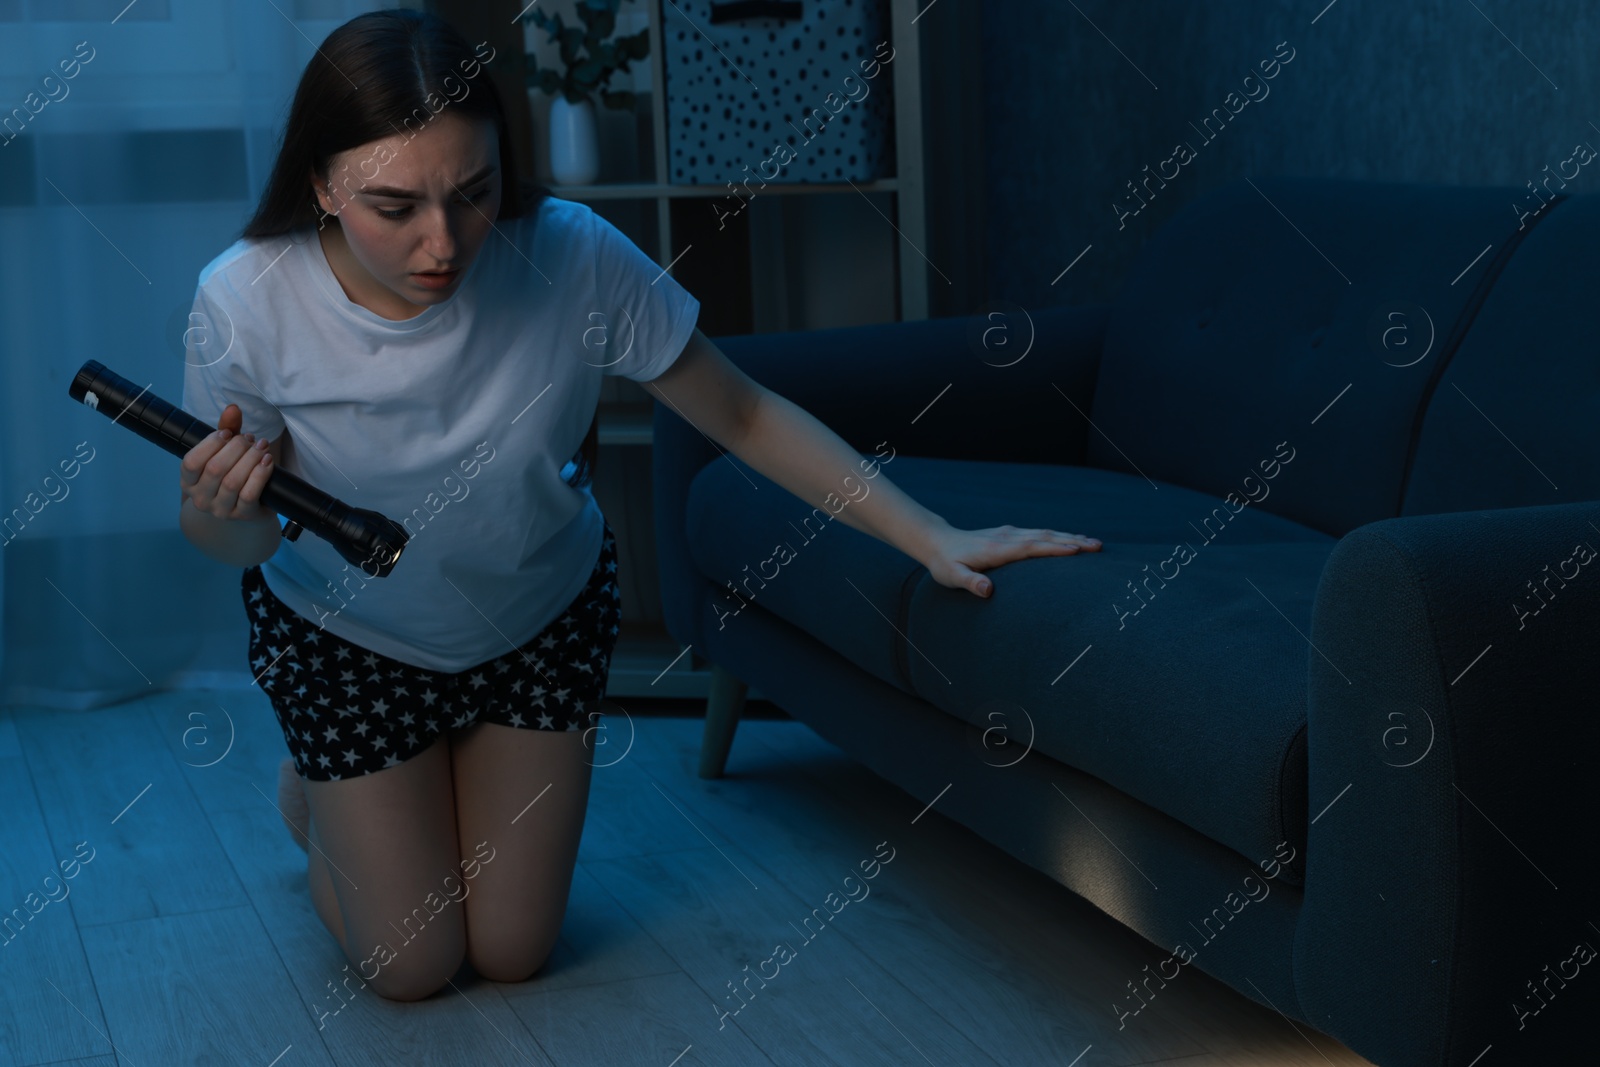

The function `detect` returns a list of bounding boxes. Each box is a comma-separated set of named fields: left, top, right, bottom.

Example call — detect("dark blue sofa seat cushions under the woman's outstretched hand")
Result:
left=688, top=456, right=1334, bottom=878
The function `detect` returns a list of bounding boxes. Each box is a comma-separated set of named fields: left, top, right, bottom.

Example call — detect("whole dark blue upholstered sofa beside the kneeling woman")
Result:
left=654, top=179, right=1600, bottom=1067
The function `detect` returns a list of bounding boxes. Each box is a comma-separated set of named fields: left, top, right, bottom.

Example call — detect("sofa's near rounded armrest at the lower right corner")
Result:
left=1294, top=501, right=1600, bottom=1065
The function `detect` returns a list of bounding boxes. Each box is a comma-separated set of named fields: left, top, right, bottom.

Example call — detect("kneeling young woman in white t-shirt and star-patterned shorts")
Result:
left=179, top=11, right=1099, bottom=1000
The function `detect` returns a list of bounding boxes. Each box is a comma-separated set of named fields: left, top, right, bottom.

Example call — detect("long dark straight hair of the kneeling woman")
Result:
left=240, top=8, right=600, bottom=488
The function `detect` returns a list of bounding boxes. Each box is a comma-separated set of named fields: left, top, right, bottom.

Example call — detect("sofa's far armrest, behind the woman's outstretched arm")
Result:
left=651, top=307, right=1106, bottom=655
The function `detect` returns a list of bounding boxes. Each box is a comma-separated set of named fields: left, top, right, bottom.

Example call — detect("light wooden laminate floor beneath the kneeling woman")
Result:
left=0, top=689, right=1366, bottom=1067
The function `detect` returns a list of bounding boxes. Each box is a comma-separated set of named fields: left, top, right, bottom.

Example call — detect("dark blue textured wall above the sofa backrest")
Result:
left=982, top=0, right=1600, bottom=307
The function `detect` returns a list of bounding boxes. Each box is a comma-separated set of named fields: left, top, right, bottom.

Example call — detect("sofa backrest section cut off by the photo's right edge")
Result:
left=1402, top=194, right=1600, bottom=521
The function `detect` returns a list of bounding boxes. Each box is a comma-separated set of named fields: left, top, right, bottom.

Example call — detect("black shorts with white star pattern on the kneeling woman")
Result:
left=240, top=523, right=622, bottom=782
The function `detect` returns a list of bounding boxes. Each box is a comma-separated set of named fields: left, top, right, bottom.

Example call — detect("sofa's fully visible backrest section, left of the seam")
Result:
left=1088, top=178, right=1539, bottom=536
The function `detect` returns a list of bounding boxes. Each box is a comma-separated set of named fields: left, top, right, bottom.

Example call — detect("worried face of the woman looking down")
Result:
left=312, top=112, right=501, bottom=318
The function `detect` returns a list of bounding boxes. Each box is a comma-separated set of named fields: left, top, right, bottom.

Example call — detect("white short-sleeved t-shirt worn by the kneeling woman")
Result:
left=182, top=197, right=699, bottom=672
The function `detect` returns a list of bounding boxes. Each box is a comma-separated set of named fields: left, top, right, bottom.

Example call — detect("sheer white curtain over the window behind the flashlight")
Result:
left=0, top=0, right=403, bottom=707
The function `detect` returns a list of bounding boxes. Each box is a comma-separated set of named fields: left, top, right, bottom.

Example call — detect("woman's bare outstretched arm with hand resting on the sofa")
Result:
left=642, top=330, right=1101, bottom=597
